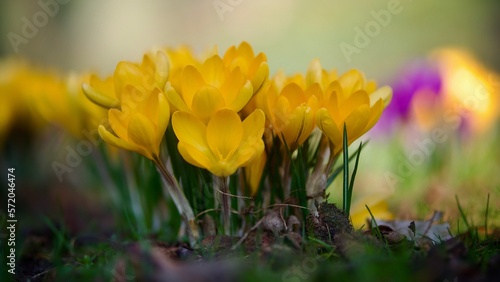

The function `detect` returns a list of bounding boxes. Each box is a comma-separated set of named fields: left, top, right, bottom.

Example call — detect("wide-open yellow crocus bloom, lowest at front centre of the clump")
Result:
left=172, top=109, right=265, bottom=177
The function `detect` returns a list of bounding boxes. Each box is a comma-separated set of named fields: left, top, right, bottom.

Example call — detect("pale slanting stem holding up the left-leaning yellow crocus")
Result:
left=154, top=157, right=200, bottom=246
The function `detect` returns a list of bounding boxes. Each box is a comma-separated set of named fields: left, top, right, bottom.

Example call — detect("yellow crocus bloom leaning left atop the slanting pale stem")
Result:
left=99, top=85, right=170, bottom=160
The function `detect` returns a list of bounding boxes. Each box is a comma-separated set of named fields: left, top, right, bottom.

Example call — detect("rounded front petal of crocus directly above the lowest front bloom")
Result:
left=191, top=86, right=225, bottom=122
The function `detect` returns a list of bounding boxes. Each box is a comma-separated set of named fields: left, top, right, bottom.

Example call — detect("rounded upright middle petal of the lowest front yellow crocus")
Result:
left=207, top=109, right=243, bottom=160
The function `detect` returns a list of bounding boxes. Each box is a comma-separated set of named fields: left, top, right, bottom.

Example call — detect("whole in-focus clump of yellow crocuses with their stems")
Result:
left=0, top=42, right=392, bottom=243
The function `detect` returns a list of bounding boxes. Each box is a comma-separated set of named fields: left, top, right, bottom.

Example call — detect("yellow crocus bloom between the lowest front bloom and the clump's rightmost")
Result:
left=263, top=74, right=321, bottom=152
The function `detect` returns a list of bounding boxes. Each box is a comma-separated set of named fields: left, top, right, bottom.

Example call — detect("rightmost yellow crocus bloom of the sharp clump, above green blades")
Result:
left=316, top=70, right=392, bottom=157
